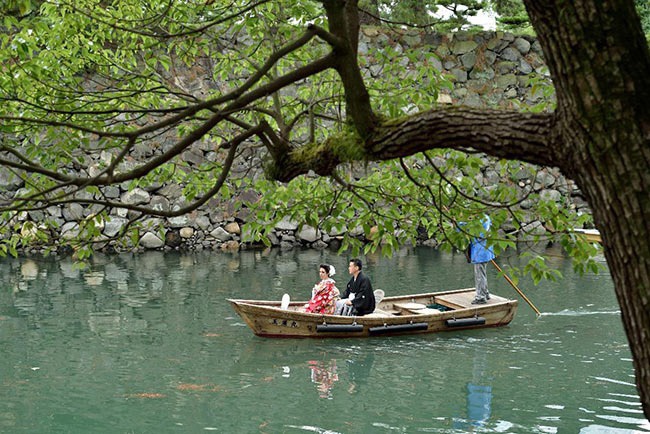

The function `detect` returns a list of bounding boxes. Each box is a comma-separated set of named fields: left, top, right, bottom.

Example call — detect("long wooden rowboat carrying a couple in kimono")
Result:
left=228, top=288, right=518, bottom=338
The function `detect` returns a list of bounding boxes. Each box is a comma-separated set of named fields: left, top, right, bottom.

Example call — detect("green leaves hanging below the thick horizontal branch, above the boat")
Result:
left=247, top=146, right=600, bottom=282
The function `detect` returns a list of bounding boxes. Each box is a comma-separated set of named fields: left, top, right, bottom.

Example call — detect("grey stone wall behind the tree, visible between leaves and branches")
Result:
left=0, top=28, right=589, bottom=254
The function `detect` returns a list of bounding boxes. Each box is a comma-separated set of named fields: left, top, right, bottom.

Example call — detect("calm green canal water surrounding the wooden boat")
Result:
left=0, top=248, right=650, bottom=433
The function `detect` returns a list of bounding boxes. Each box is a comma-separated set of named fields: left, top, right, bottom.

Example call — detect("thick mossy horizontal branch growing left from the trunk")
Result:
left=272, top=108, right=563, bottom=182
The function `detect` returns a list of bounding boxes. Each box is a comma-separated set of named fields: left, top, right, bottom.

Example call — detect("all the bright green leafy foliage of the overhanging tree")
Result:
left=0, top=0, right=594, bottom=276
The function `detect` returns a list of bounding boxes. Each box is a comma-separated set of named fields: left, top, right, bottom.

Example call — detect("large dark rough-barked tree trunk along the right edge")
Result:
left=525, top=0, right=650, bottom=419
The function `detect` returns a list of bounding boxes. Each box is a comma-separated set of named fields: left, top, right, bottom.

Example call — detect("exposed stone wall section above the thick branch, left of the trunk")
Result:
left=359, top=28, right=553, bottom=109
